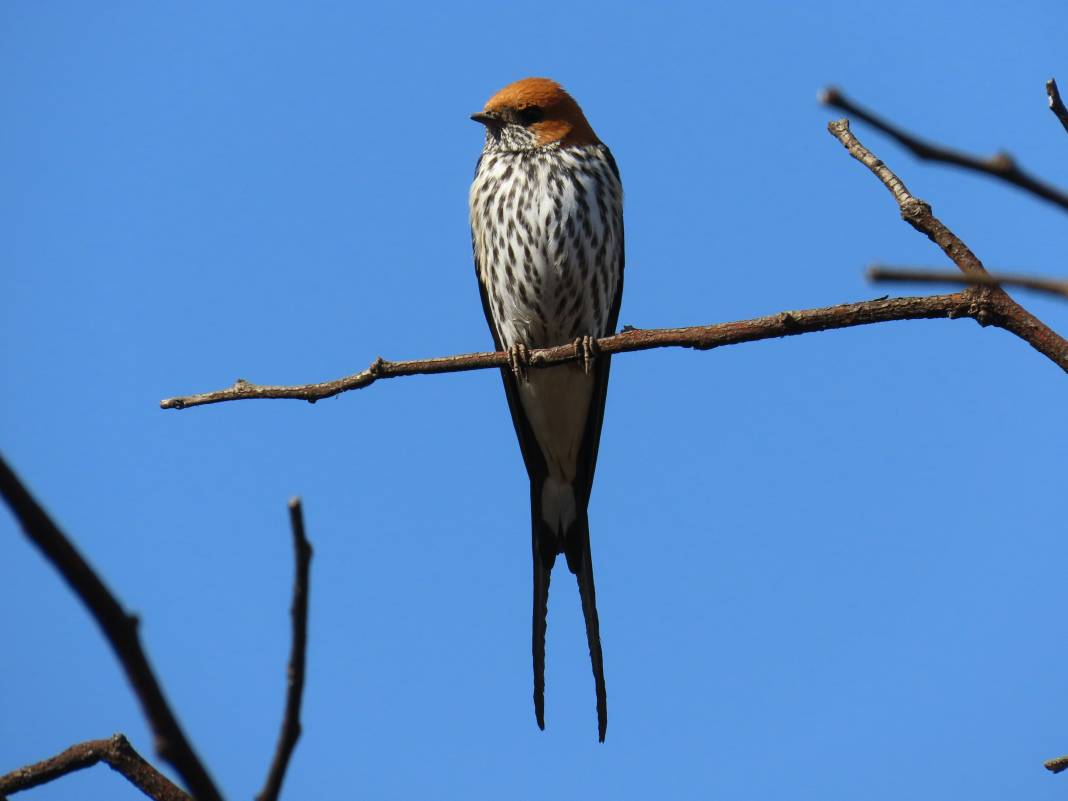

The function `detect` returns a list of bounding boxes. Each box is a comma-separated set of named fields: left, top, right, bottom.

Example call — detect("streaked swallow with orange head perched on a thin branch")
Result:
left=469, top=78, right=624, bottom=742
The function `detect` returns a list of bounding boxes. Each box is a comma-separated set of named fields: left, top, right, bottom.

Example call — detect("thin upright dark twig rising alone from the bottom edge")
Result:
left=256, top=498, right=312, bottom=801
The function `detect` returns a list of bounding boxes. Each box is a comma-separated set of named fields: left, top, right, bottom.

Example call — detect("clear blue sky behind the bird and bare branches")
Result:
left=0, top=0, right=1068, bottom=801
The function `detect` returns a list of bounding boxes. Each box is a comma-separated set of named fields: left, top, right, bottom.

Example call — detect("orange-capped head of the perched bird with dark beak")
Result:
left=471, top=78, right=600, bottom=151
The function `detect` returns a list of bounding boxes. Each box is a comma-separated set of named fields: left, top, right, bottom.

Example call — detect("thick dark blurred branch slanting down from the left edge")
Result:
left=0, top=458, right=221, bottom=801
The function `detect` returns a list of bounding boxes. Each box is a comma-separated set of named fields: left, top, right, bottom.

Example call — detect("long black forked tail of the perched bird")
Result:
left=531, top=492, right=608, bottom=742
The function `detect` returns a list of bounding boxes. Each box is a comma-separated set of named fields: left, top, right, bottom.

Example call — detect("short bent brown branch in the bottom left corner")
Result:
left=0, top=734, right=190, bottom=801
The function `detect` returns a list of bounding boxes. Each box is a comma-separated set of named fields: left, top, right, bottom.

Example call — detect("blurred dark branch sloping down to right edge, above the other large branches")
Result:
left=819, top=87, right=1068, bottom=210
